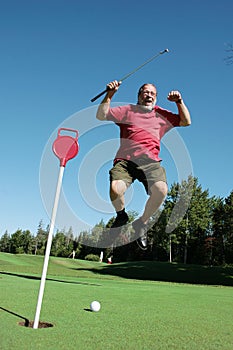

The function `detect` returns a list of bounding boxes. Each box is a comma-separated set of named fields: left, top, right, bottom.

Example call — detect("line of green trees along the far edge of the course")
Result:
left=0, top=176, right=233, bottom=265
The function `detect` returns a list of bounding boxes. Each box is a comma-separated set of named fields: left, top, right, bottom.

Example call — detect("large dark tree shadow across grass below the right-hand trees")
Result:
left=73, top=261, right=233, bottom=287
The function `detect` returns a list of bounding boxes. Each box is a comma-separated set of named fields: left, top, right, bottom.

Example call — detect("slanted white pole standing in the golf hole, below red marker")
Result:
left=33, top=166, right=65, bottom=329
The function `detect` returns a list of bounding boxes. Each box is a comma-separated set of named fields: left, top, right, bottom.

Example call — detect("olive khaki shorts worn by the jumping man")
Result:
left=109, top=158, right=167, bottom=194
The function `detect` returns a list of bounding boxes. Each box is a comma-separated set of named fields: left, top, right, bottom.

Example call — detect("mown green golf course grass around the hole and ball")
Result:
left=0, top=253, right=233, bottom=350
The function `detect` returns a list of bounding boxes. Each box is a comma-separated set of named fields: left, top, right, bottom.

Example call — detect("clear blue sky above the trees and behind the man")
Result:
left=0, top=0, right=233, bottom=235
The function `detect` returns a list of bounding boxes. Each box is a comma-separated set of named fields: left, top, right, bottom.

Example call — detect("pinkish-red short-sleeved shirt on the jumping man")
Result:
left=107, top=104, right=180, bottom=161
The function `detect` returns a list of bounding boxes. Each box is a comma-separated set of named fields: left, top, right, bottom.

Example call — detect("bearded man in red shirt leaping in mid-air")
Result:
left=96, top=80, right=191, bottom=250
